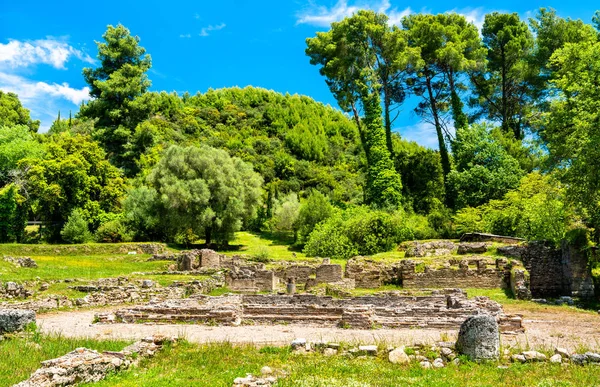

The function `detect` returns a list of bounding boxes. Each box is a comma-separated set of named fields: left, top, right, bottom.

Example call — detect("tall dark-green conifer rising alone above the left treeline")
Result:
left=79, top=24, right=152, bottom=172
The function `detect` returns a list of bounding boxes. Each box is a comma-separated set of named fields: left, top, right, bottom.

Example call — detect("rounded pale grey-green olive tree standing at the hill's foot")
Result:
left=147, top=145, right=262, bottom=245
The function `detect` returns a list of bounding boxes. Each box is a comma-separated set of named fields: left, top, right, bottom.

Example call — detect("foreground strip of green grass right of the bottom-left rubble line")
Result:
left=88, top=342, right=600, bottom=387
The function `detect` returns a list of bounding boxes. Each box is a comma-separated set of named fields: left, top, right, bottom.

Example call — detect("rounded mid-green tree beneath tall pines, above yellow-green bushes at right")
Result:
left=448, top=124, right=523, bottom=208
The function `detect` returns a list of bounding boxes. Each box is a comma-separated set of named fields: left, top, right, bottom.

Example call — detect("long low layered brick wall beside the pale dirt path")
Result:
left=96, top=289, right=522, bottom=332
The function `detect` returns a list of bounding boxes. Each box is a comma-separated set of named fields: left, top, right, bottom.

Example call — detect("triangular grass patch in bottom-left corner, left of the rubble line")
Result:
left=0, top=334, right=129, bottom=387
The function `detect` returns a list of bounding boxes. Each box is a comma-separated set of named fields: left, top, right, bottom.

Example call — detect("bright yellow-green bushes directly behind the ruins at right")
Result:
left=454, top=172, right=575, bottom=242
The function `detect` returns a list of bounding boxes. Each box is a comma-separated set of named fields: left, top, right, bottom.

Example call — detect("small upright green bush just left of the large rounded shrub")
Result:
left=295, top=190, right=333, bottom=246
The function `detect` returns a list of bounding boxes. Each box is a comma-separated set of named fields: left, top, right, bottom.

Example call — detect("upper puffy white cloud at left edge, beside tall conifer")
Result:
left=0, top=39, right=94, bottom=69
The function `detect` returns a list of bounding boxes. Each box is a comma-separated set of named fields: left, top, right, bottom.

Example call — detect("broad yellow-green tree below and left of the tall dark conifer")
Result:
left=19, top=133, right=125, bottom=242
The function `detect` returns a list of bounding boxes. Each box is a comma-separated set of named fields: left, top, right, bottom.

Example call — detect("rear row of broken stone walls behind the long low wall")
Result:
left=163, top=247, right=524, bottom=292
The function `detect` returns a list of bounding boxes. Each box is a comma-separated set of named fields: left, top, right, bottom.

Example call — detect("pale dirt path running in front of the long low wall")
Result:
left=38, top=308, right=600, bottom=350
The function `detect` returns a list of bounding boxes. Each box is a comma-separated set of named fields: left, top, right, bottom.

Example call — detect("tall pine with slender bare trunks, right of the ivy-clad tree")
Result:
left=402, top=13, right=484, bottom=192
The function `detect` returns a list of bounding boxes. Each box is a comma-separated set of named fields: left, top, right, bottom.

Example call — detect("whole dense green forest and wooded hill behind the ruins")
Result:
left=0, top=8, right=600, bottom=258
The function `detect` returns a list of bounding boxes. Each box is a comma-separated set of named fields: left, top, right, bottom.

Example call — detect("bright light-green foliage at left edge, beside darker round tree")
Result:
left=0, top=124, right=44, bottom=186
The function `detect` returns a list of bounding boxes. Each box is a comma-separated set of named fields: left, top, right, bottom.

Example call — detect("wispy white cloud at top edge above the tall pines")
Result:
left=296, top=0, right=412, bottom=27
